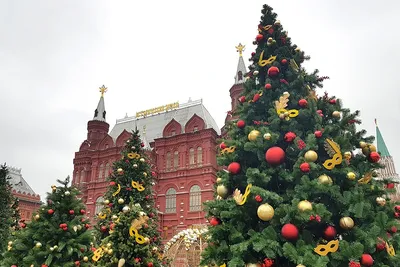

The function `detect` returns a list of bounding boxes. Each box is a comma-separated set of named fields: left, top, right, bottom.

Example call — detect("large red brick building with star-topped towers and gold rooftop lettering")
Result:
left=73, top=47, right=246, bottom=238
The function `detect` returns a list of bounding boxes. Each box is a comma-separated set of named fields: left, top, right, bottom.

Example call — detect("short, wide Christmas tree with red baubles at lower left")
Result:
left=0, top=177, right=93, bottom=267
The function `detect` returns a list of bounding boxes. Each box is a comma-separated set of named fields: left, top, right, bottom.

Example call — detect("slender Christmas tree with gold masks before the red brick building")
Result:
left=93, top=130, right=162, bottom=267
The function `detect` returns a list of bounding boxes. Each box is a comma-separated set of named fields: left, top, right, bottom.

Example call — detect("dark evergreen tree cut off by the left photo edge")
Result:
left=0, top=164, right=18, bottom=259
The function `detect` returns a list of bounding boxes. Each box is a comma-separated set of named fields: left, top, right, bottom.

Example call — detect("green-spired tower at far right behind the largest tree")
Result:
left=375, top=119, right=400, bottom=200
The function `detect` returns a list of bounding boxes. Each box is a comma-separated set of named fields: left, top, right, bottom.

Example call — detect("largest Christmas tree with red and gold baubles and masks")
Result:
left=203, top=5, right=400, bottom=267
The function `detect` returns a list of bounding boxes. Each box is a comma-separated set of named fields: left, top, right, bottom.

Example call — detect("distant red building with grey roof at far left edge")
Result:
left=7, top=166, right=42, bottom=222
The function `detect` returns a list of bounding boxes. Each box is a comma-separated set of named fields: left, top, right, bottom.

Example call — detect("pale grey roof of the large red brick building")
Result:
left=110, top=99, right=220, bottom=143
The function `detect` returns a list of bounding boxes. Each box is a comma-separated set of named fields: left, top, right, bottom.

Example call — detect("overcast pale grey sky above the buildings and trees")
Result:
left=0, top=0, right=400, bottom=201
